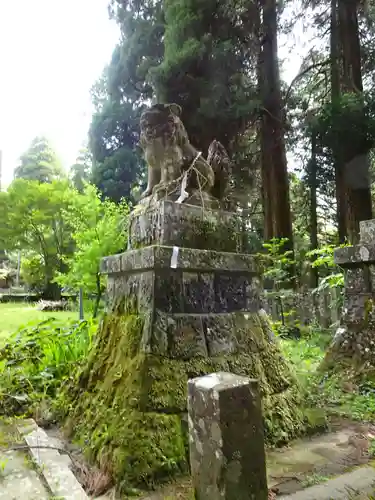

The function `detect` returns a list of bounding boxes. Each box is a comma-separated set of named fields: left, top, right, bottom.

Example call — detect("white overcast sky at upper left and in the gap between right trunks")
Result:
left=0, top=0, right=302, bottom=187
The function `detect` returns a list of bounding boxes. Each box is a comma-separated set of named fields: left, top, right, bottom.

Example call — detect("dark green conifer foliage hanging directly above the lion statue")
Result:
left=150, top=0, right=259, bottom=151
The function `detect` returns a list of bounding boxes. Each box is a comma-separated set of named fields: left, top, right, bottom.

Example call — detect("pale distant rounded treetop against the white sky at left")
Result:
left=14, top=137, right=64, bottom=182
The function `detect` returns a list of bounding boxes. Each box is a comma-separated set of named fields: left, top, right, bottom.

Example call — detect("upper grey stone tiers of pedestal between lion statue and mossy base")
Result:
left=102, top=201, right=268, bottom=368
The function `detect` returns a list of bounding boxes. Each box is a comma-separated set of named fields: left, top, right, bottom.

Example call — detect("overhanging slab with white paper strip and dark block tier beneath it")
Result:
left=102, top=247, right=261, bottom=314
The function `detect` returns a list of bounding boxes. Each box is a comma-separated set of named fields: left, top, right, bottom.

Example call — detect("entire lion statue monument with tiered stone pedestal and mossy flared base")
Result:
left=66, top=101, right=306, bottom=488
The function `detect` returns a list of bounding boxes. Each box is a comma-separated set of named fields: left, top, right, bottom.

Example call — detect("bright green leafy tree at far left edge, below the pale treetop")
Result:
left=0, top=179, right=79, bottom=298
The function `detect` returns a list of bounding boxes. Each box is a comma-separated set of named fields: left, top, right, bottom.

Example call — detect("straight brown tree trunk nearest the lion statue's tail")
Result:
left=261, top=0, right=293, bottom=249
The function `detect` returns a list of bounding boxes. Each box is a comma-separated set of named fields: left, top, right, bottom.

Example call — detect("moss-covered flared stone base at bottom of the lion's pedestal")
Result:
left=59, top=307, right=320, bottom=487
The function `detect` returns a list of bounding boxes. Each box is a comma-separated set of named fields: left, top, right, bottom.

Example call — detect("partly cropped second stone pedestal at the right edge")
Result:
left=332, top=219, right=375, bottom=368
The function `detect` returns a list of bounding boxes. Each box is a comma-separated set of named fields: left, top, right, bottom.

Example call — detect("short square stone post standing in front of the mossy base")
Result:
left=188, top=372, right=268, bottom=500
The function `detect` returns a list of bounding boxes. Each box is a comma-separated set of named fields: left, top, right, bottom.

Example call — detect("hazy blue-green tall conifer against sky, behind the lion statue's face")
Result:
left=89, top=0, right=164, bottom=201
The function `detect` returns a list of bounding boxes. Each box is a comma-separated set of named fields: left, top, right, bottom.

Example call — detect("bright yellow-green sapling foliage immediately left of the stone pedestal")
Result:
left=56, top=184, right=129, bottom=316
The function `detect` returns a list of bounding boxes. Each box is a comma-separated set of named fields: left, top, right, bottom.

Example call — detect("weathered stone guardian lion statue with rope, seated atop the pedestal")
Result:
left=140, top=104, right=231, bottom=207
